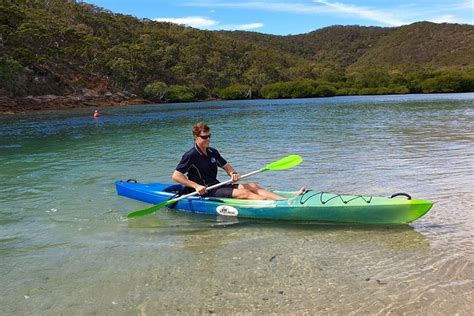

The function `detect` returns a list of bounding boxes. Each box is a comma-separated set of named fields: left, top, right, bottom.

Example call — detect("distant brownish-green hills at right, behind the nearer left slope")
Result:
left=226, top=22, right=474, bottom=71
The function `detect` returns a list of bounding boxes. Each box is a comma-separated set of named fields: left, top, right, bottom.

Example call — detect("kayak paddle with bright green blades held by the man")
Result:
left=127, top=155, right=303, bottom=218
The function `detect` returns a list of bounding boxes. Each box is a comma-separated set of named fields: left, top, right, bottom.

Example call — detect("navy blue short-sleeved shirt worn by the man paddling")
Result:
left=176, top=144, right=227, bottom=186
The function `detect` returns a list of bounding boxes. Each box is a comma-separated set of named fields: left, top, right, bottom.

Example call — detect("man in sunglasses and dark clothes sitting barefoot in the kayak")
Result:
left=172, top=122, right=304, bottom=200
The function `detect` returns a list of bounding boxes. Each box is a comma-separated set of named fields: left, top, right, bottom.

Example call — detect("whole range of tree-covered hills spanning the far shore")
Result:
left=0, top=0, right=474, bottom=107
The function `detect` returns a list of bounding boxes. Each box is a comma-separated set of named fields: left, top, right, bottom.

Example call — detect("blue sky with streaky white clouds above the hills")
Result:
left=84, top=0, right=474, bottom=35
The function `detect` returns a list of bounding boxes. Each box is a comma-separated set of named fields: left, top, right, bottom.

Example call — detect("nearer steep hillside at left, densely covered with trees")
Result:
left=0, top=0, right=305, bottom=95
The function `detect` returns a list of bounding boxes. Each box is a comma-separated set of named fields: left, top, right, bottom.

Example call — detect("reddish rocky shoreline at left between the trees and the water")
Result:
left=0, top=92, right=150, bottom=114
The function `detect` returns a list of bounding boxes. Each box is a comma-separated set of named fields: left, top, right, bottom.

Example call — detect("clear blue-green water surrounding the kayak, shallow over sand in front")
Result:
left=0, top=94, right=474, bottom=315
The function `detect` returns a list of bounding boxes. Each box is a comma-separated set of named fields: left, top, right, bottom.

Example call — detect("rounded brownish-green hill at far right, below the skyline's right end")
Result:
left=350, top=22, right=474, bottom=71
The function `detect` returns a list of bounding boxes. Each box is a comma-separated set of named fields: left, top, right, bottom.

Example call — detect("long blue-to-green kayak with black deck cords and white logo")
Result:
left=115, top=180, right=433, bottom=224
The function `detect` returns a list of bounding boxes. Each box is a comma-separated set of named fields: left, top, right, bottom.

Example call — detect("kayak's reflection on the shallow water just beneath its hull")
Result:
left=128, top=210, right=430, bottom=250
